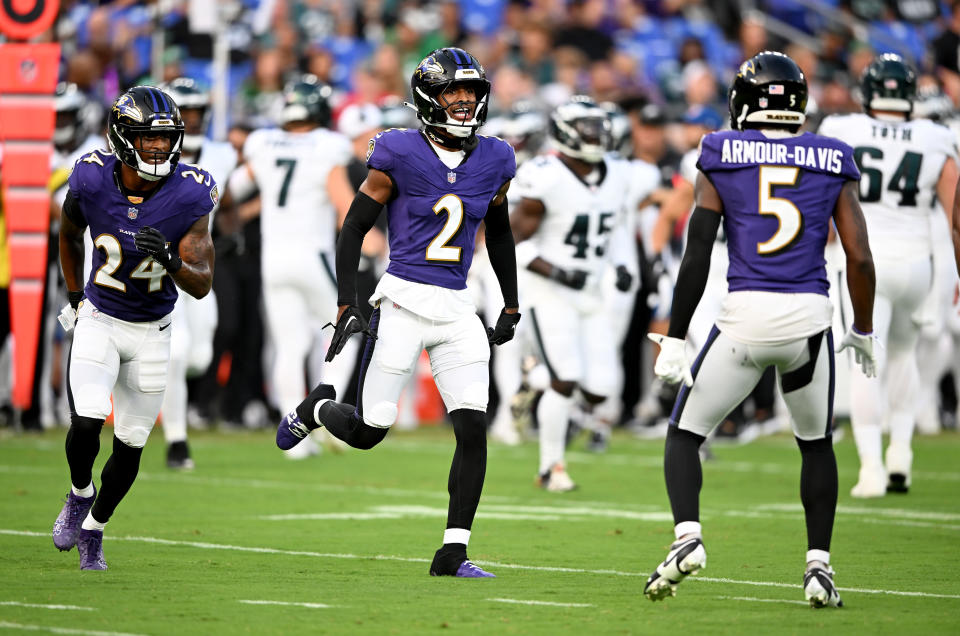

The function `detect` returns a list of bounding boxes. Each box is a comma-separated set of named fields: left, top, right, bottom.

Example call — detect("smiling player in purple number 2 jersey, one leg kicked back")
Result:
left=277, top=48, right=520, bottom=578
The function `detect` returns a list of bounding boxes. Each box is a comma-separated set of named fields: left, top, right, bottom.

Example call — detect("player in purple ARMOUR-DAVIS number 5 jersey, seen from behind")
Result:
left=644, top=51, right=875, bottom=607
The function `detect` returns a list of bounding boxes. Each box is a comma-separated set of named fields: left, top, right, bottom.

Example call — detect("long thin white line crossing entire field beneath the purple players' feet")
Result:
left=0, top=528, right=960, bottom=600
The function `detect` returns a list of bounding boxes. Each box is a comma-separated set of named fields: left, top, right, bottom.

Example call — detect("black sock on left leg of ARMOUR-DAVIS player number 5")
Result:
left=663, top=426, right=706, bottom=524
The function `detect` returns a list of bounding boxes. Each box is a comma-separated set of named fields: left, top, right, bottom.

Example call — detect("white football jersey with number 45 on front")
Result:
left=511, top=155, right=636, bottom=300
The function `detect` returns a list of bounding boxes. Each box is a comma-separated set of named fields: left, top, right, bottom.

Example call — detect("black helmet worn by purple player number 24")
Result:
left=107, top=86, right=183, bottom=181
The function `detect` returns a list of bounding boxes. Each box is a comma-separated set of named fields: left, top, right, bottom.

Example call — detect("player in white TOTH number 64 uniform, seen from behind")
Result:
left=820, top=54, right=960, bottom=497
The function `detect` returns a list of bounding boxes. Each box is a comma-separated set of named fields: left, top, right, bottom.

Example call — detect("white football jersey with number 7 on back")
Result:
left=243, top=128, right=353, bottom=252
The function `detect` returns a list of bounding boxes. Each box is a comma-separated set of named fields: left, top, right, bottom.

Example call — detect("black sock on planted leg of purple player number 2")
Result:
left=444, top=409, right=487, bottom=528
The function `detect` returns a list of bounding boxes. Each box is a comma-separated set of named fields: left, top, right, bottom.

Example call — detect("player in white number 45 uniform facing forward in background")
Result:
left=510, top=96, right=636, bottom=491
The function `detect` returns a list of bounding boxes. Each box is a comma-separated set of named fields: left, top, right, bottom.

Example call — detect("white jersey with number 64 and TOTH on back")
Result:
left=819, top=113, right=957, bottom=258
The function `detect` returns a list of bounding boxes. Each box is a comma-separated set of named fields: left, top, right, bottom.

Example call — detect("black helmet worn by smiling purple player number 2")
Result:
left=410, top=47, right=490, bottom=138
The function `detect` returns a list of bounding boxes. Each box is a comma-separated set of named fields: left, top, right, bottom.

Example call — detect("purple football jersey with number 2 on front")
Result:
left=367, top=129, right=517, bottom=289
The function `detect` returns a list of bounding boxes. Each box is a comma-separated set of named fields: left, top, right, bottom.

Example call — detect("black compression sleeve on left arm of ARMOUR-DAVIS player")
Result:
left=667, top=207, right=720, bottom=339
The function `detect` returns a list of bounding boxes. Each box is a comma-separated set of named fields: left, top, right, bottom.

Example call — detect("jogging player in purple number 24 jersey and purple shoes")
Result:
left=53, top=86, right=219, bottom=570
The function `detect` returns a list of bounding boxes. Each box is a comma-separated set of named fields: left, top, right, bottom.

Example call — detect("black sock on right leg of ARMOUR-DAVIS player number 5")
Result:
left=797, top=436, right=839, bottom=552
